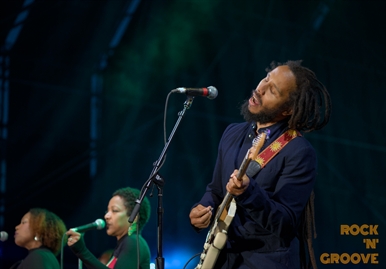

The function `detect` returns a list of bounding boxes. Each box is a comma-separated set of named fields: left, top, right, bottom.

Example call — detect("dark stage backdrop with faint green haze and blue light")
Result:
left=0, top=0, right=386, bottom=269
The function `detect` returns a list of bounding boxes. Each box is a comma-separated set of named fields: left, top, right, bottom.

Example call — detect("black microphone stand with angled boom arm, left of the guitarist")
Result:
left=129, top=95, right=194, bottom=269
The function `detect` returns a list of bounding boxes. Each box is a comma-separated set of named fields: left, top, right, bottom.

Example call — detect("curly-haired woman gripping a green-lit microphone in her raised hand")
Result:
left=67, top=187, right=150, bottom=269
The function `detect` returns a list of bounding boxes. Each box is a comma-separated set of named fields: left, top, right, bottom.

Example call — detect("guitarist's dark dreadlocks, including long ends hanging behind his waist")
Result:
left=266, top=60, right=331, bottom=269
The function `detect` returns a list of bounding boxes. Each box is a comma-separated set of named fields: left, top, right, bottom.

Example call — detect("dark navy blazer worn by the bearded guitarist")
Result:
left=199, top=122, right=317, bottom=268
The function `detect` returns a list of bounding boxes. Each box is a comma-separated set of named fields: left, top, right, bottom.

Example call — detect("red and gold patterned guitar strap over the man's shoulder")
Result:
left=255, top=129, right=302, bottom=168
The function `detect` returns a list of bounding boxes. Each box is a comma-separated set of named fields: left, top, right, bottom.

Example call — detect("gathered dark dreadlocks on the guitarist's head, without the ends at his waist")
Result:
left=266, top=60, right=331, bottom=132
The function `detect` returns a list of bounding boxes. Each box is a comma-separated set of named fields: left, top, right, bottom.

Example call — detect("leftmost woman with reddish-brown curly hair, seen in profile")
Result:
left=11, top=208, right=67, bottom=269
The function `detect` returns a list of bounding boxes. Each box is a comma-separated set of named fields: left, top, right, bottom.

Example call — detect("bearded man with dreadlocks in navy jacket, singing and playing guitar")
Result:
left=189, top=61, right=331, bottom=269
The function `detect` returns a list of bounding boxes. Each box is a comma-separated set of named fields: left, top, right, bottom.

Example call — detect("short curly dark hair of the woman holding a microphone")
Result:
left=113, top=187, right=151, bottom=232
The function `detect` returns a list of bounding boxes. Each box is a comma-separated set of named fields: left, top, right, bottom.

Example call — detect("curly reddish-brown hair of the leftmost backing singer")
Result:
left=28, top=208, right=67, bottom=255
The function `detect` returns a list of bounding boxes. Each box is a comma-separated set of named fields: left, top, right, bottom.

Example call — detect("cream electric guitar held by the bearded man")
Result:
left=195, top=132, right=267, bottom=269
